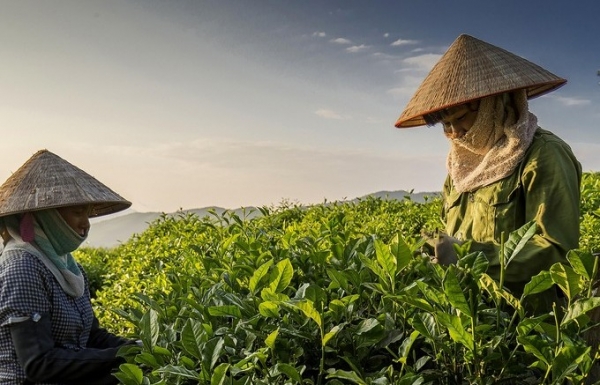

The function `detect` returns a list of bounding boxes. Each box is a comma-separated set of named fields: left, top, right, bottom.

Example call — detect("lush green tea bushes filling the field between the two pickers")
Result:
left=77, top=173, right=600, bottom=385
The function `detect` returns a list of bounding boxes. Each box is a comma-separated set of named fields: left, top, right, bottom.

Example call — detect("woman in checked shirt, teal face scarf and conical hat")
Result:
left=0, top=150, right=132, bottom=384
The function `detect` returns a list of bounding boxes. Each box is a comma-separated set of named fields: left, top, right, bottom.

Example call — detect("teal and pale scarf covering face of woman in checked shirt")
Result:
left=4, top=209, right=87, bottom=298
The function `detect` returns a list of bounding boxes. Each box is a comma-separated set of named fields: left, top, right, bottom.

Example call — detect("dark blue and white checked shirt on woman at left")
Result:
left=0, top=250, right=94, bottom=385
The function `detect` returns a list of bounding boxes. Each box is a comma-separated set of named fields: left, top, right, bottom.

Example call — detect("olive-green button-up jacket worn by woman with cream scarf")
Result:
left=442, top=128, right=581, bottom=287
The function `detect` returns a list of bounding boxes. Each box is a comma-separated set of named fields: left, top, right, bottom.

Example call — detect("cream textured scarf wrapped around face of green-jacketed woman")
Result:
left=447, top=90, right=538, bottom=193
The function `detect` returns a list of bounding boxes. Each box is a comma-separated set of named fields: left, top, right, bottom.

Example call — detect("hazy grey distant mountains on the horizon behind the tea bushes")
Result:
left=84, top=190, right=439, bottom=248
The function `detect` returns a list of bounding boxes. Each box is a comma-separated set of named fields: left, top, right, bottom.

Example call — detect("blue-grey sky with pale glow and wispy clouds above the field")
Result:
left=0, top=0, right=600, bottom=212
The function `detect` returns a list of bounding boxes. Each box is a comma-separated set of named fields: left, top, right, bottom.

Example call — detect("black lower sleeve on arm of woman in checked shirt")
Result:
left=9, top=314, right=122, bottom=385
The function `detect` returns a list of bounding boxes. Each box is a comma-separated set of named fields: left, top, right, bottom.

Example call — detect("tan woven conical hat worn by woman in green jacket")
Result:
left=395, top=35, right=567, bottom=128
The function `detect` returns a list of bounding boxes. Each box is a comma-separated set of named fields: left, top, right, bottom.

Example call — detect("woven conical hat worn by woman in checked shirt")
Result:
left=0, top=150, right=131, bottom=217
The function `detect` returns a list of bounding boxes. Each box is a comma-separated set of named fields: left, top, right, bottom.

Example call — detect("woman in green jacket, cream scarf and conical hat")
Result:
left=396, top=35, right=581, bottom=308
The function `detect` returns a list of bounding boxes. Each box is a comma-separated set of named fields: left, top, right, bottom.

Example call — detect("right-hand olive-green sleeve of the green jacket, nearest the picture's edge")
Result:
left=471, top=137, right=581, bottom=284
